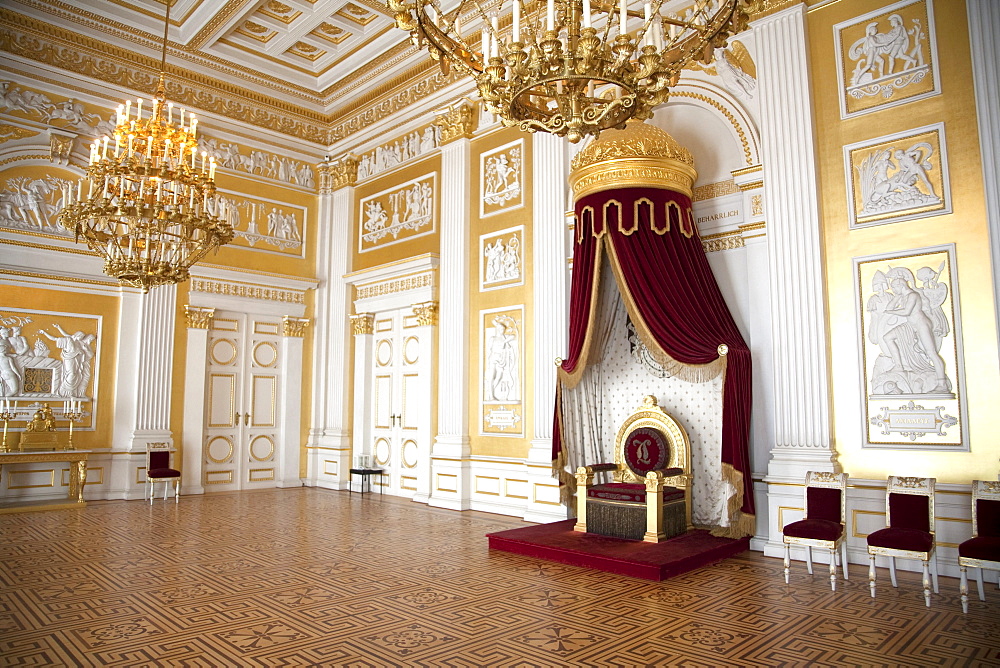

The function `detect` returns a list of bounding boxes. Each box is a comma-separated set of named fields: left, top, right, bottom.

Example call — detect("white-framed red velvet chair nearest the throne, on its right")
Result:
left=781, top=471, right=848, bottom=591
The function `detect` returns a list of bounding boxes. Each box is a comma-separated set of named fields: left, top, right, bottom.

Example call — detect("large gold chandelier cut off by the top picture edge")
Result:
left=387, top=0, right=747, bottom=142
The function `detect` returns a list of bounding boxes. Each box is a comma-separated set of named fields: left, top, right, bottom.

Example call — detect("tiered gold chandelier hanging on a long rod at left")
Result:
left=59, top=0, right=233, bottom=292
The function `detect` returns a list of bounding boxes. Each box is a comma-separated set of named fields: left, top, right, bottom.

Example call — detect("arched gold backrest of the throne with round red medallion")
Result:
left=615, top=395, right=691, bottom=487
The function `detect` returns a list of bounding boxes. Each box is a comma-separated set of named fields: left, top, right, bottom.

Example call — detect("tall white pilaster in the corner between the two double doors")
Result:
left=306, top=170, right=354, bottom=488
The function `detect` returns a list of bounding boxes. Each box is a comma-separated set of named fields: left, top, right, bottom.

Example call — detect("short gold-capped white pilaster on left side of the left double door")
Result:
left=181, top=306, right=215, bottom=494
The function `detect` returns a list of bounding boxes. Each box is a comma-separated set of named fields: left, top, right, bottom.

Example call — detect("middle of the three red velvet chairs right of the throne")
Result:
left=868, top=476, right=938, bottom=607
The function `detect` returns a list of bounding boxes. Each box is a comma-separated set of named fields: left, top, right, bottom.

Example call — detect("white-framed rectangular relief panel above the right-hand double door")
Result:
left=358, top=172, right=437, bottom=253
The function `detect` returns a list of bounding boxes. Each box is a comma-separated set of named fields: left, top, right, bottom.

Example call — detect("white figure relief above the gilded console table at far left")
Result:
left=0, top=309, right=98, bottom=418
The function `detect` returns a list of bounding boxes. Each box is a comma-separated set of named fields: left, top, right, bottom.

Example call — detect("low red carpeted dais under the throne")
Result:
left=486, top=519, right=750, bottom=580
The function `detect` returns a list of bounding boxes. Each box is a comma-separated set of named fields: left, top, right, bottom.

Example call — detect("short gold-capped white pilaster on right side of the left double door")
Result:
left=275, top=316, right=309, bottom=487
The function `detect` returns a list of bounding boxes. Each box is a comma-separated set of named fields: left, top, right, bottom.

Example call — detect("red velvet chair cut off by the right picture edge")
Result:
left=958, top=480, right=1000, bottom=612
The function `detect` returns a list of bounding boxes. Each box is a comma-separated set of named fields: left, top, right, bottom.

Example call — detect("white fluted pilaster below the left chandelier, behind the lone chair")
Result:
left=108, top=285, right=183, bottom=499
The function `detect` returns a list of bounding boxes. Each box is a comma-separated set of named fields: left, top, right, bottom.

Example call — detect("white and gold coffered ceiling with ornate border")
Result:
left=0, top=0, right=428, bottom=126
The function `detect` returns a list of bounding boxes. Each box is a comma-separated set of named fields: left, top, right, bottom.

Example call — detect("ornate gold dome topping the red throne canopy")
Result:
left=569, top=123, right=698, bottom=200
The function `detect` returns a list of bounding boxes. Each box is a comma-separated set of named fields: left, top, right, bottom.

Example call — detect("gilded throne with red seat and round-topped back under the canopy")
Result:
left=573, top=395, right=692, bottom=543
